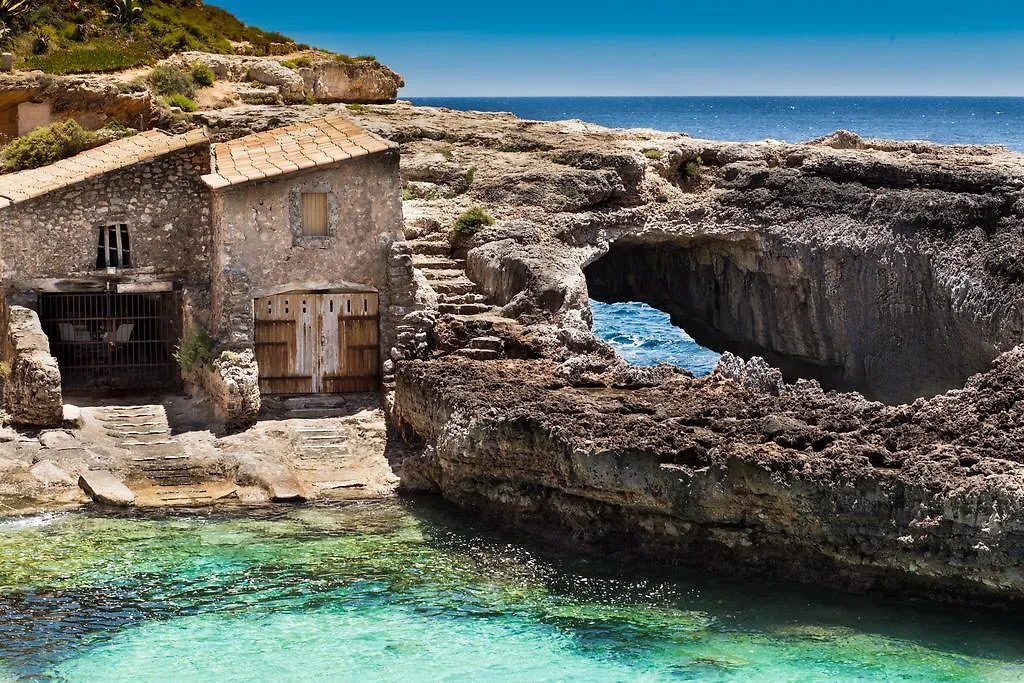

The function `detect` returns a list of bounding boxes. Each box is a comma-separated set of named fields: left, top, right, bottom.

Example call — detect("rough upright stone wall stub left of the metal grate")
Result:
left=3, top=306, right=63, bottom=427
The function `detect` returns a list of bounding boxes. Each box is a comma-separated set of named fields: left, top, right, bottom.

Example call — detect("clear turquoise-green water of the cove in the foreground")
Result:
left=0, top=503, right=1024, bottom=682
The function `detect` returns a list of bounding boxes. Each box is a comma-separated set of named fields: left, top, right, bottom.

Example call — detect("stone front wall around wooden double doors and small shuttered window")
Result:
left=213, top=151, right=402, bottom=348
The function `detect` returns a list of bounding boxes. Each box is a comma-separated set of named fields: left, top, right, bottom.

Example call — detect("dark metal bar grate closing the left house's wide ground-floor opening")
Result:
left=39, top=292, right=180, bottom=391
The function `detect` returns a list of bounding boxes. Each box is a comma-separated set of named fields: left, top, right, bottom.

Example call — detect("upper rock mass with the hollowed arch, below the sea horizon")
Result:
left=329, top=106, right=1024, bottom=402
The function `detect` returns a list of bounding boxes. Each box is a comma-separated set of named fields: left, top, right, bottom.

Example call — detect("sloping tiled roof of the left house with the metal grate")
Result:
left=0, top=130, right=209, bottom=209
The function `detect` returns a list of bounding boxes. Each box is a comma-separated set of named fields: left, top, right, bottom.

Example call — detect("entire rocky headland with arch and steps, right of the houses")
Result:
left=2, top=98, right=1024, bottom=606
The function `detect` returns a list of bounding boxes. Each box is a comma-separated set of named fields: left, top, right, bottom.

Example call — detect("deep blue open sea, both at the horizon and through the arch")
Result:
left=413, top=97, right=1024, bottom=375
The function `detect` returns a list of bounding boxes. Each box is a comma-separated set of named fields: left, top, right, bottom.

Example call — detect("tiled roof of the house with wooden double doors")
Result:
left=203, top=117, right=397, bottom=189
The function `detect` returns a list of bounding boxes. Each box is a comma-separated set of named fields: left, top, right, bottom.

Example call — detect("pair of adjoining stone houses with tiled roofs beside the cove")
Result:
left=0, top=118, right=402, bottom=422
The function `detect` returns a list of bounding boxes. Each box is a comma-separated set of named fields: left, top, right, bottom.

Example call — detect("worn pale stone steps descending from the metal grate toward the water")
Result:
left=92, top=404, right=221, bottom=506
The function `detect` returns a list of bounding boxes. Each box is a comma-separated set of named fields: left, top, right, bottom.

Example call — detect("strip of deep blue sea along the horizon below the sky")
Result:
left=413, top=97, right=1024, bottom=152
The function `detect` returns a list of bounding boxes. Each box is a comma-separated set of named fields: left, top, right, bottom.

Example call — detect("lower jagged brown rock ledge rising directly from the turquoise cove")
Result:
left=395, top=349, right=1024, bottom=606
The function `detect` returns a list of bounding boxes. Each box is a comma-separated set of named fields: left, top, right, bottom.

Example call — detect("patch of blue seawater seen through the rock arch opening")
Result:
left=590, top=299, right=719, bottom=377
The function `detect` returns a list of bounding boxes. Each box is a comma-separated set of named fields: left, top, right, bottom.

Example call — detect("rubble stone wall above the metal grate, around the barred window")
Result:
left=0, top=144, right=211, bottom=289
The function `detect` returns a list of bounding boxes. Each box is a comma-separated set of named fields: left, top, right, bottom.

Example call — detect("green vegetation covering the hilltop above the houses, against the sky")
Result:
left=0, top=0, right=306, bottom=74
